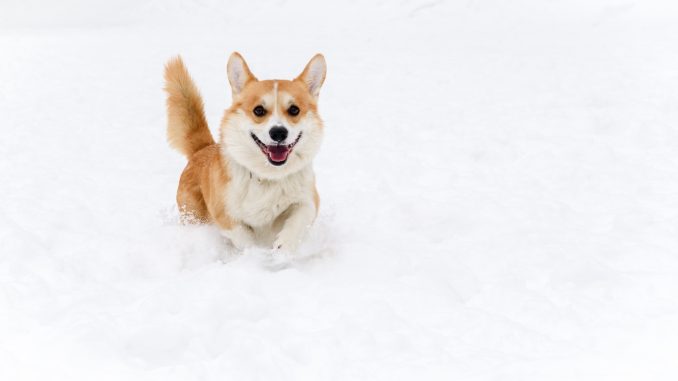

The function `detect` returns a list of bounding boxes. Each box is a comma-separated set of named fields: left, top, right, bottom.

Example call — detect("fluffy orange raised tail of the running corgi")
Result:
left=165, top=56, right=214, bottom=158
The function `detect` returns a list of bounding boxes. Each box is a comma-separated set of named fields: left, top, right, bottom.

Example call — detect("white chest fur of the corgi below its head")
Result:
left=226, top=164, right=314, bottom=228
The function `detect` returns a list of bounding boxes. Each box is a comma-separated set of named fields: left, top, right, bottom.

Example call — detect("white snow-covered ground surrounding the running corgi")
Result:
left=0, top=0, right=678, bottom=381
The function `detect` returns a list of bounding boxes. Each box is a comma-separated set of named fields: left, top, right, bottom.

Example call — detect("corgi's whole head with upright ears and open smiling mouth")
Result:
left=221, top=53, right=326, bottom=179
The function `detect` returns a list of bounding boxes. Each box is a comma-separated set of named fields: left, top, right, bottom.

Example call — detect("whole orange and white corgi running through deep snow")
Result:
left=165, top=52, right=327, bottom=252
